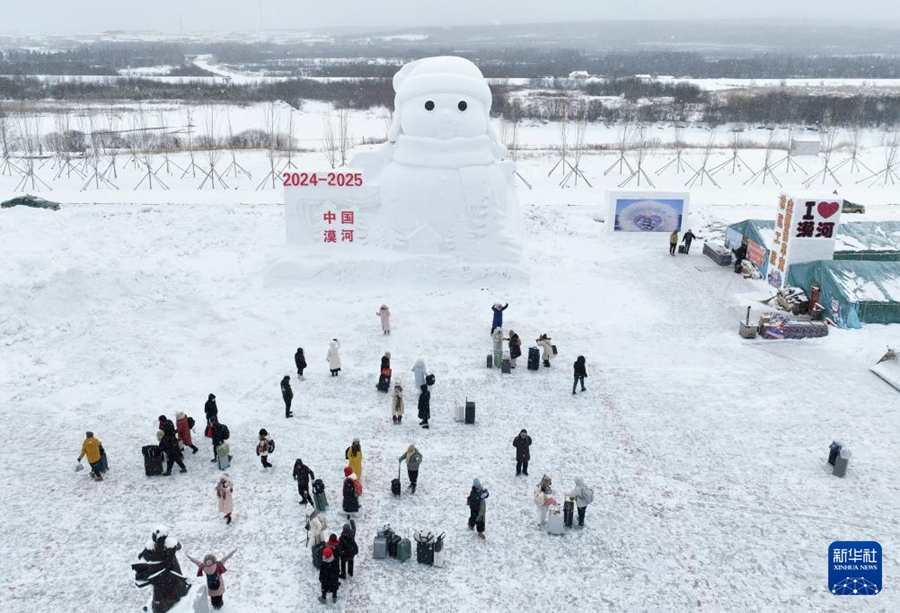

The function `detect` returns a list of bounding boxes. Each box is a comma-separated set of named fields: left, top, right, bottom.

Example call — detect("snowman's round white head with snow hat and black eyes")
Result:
left=389, top=56, right=496, bottom=141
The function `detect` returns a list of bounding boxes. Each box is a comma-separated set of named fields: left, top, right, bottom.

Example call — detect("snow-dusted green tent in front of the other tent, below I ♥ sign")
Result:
left=787, top=260, right=900, bottom=328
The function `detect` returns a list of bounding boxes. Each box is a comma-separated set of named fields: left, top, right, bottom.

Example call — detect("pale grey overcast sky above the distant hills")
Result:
left=0, top=0, right=900, bottom=34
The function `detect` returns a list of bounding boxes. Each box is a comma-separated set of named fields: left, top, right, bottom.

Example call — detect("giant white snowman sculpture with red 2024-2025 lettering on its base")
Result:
left=267, top=57, right=526, bottom=281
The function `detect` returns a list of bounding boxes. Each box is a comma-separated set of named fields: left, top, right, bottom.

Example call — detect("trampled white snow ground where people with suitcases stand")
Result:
left=0, top=146, right=900, bottom=612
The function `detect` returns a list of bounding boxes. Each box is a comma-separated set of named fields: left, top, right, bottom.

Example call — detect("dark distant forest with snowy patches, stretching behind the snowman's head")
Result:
left=0, top=42, right=900, bottom=126
